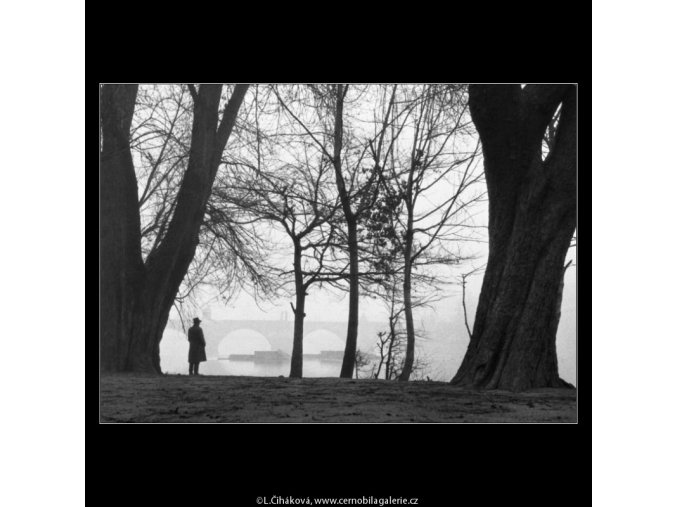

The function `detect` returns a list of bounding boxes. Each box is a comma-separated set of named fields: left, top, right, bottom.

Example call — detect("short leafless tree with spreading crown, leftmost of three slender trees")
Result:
left=206, top=88, right=345, bottom=377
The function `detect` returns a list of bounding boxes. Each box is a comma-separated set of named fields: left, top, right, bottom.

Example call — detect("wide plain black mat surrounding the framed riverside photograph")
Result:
left=86, top=8, right=591, bottom=506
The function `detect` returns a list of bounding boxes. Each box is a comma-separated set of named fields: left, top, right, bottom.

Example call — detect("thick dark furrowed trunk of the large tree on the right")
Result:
left=452, top=85, right=576, bottom=390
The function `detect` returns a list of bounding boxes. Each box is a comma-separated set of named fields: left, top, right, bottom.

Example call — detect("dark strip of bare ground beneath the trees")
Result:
left=100, top=374, right=576, bottom=423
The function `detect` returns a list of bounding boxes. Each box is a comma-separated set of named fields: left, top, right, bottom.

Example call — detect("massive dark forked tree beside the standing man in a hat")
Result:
left=100, top=85, right=247, bottom=373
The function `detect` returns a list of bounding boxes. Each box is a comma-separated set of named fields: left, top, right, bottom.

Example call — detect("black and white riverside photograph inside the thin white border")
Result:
left=99, top=83, right=578, bottom=424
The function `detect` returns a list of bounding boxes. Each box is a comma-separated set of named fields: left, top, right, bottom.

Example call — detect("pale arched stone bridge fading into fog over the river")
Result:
left=168, top=317, right=384, bottom=357
